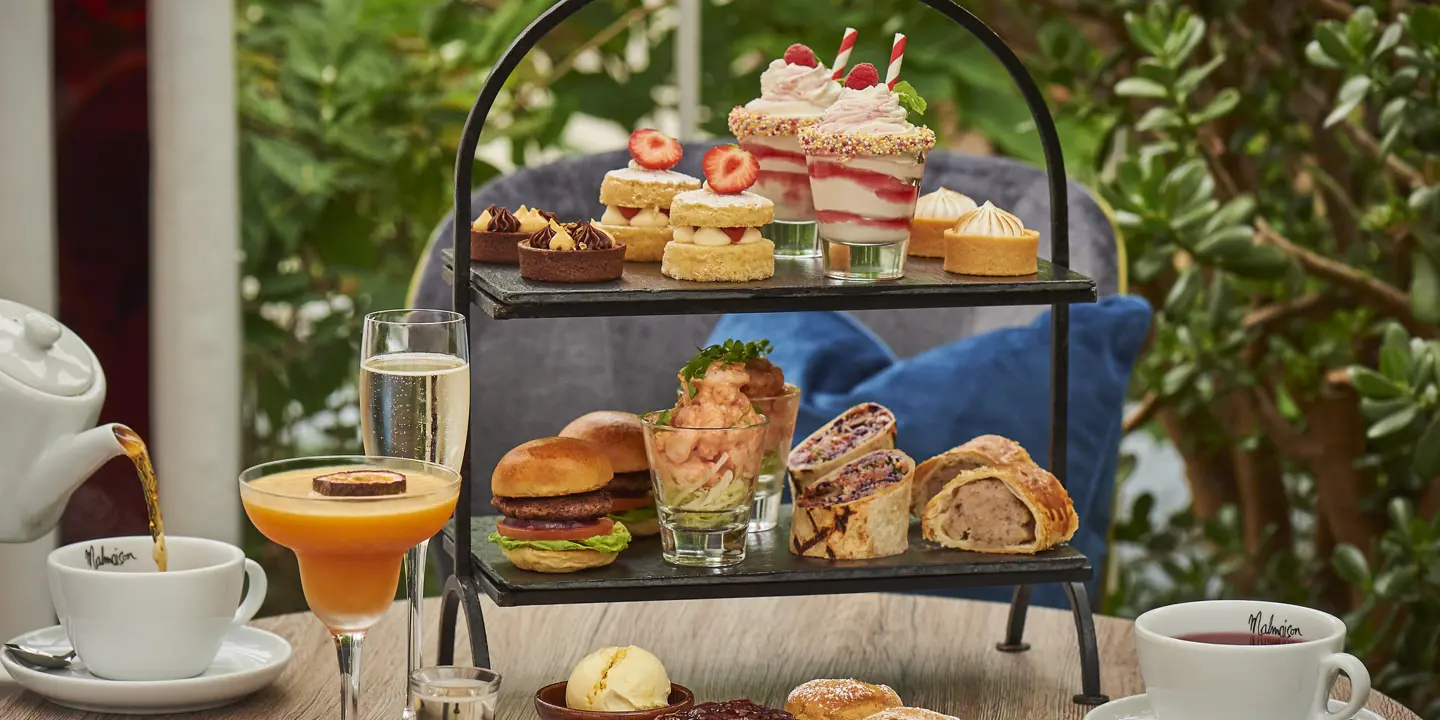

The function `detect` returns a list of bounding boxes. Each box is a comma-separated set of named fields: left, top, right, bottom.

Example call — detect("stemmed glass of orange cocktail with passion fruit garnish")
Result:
left=240, top=456, right=459, bottom=720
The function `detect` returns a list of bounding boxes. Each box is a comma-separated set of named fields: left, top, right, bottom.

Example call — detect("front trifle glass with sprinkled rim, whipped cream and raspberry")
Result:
left=799, top=63, right=935, bottom=281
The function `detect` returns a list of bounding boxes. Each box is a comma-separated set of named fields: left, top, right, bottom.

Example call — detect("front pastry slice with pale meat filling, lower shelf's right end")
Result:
left=920, top=464, right=1080, bottom=554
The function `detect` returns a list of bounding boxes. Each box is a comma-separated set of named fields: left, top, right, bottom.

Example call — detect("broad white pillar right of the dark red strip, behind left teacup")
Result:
left=150, top=0, right=242, bottom=544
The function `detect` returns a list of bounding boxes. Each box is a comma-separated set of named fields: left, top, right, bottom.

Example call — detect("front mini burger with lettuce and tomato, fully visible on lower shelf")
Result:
left=490, top=438, right=631, bottom=573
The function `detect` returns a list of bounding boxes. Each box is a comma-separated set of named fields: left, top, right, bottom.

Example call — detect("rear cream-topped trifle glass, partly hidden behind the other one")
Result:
left=729, top=45, right=840, bottom=258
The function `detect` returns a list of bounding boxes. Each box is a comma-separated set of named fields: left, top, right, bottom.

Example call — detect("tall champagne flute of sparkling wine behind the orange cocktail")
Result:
left=360, top=310, right=469, bottom=717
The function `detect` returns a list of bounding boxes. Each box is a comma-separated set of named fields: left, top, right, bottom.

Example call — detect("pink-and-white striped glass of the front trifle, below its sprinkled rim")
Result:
left=805, top=153, right=924, bottom=281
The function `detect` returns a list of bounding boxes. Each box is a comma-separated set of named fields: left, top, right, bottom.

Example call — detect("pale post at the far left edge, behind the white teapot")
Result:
left=0, top=0, right=59, bottom=656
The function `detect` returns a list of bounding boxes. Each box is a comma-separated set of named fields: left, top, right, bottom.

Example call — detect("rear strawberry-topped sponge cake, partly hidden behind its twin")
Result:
left=596, top=128, right=700, bottom=262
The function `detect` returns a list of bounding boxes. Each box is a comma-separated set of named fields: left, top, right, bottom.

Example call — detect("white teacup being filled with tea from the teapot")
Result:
left=48, top=536, right=266, bottom=680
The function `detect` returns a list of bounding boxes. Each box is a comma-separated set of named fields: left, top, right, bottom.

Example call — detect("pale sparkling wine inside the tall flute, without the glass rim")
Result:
left=360, top=353, right=469, bottom=469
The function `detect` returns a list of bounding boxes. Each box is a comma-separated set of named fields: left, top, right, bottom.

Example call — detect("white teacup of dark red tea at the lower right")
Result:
left=1135, top=600, right=1369, bottom=720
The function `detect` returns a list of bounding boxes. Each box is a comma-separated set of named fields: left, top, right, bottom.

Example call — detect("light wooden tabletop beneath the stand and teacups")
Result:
left=0, top=595, right=1418, bottom=720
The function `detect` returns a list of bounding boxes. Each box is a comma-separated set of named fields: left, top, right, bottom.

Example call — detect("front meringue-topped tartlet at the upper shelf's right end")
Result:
left=945, top=200, right=1040, bottom=276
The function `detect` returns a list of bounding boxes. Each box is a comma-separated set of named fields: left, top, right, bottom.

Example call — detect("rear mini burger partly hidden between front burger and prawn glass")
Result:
left=560, top=410, right=660, bottom=537
